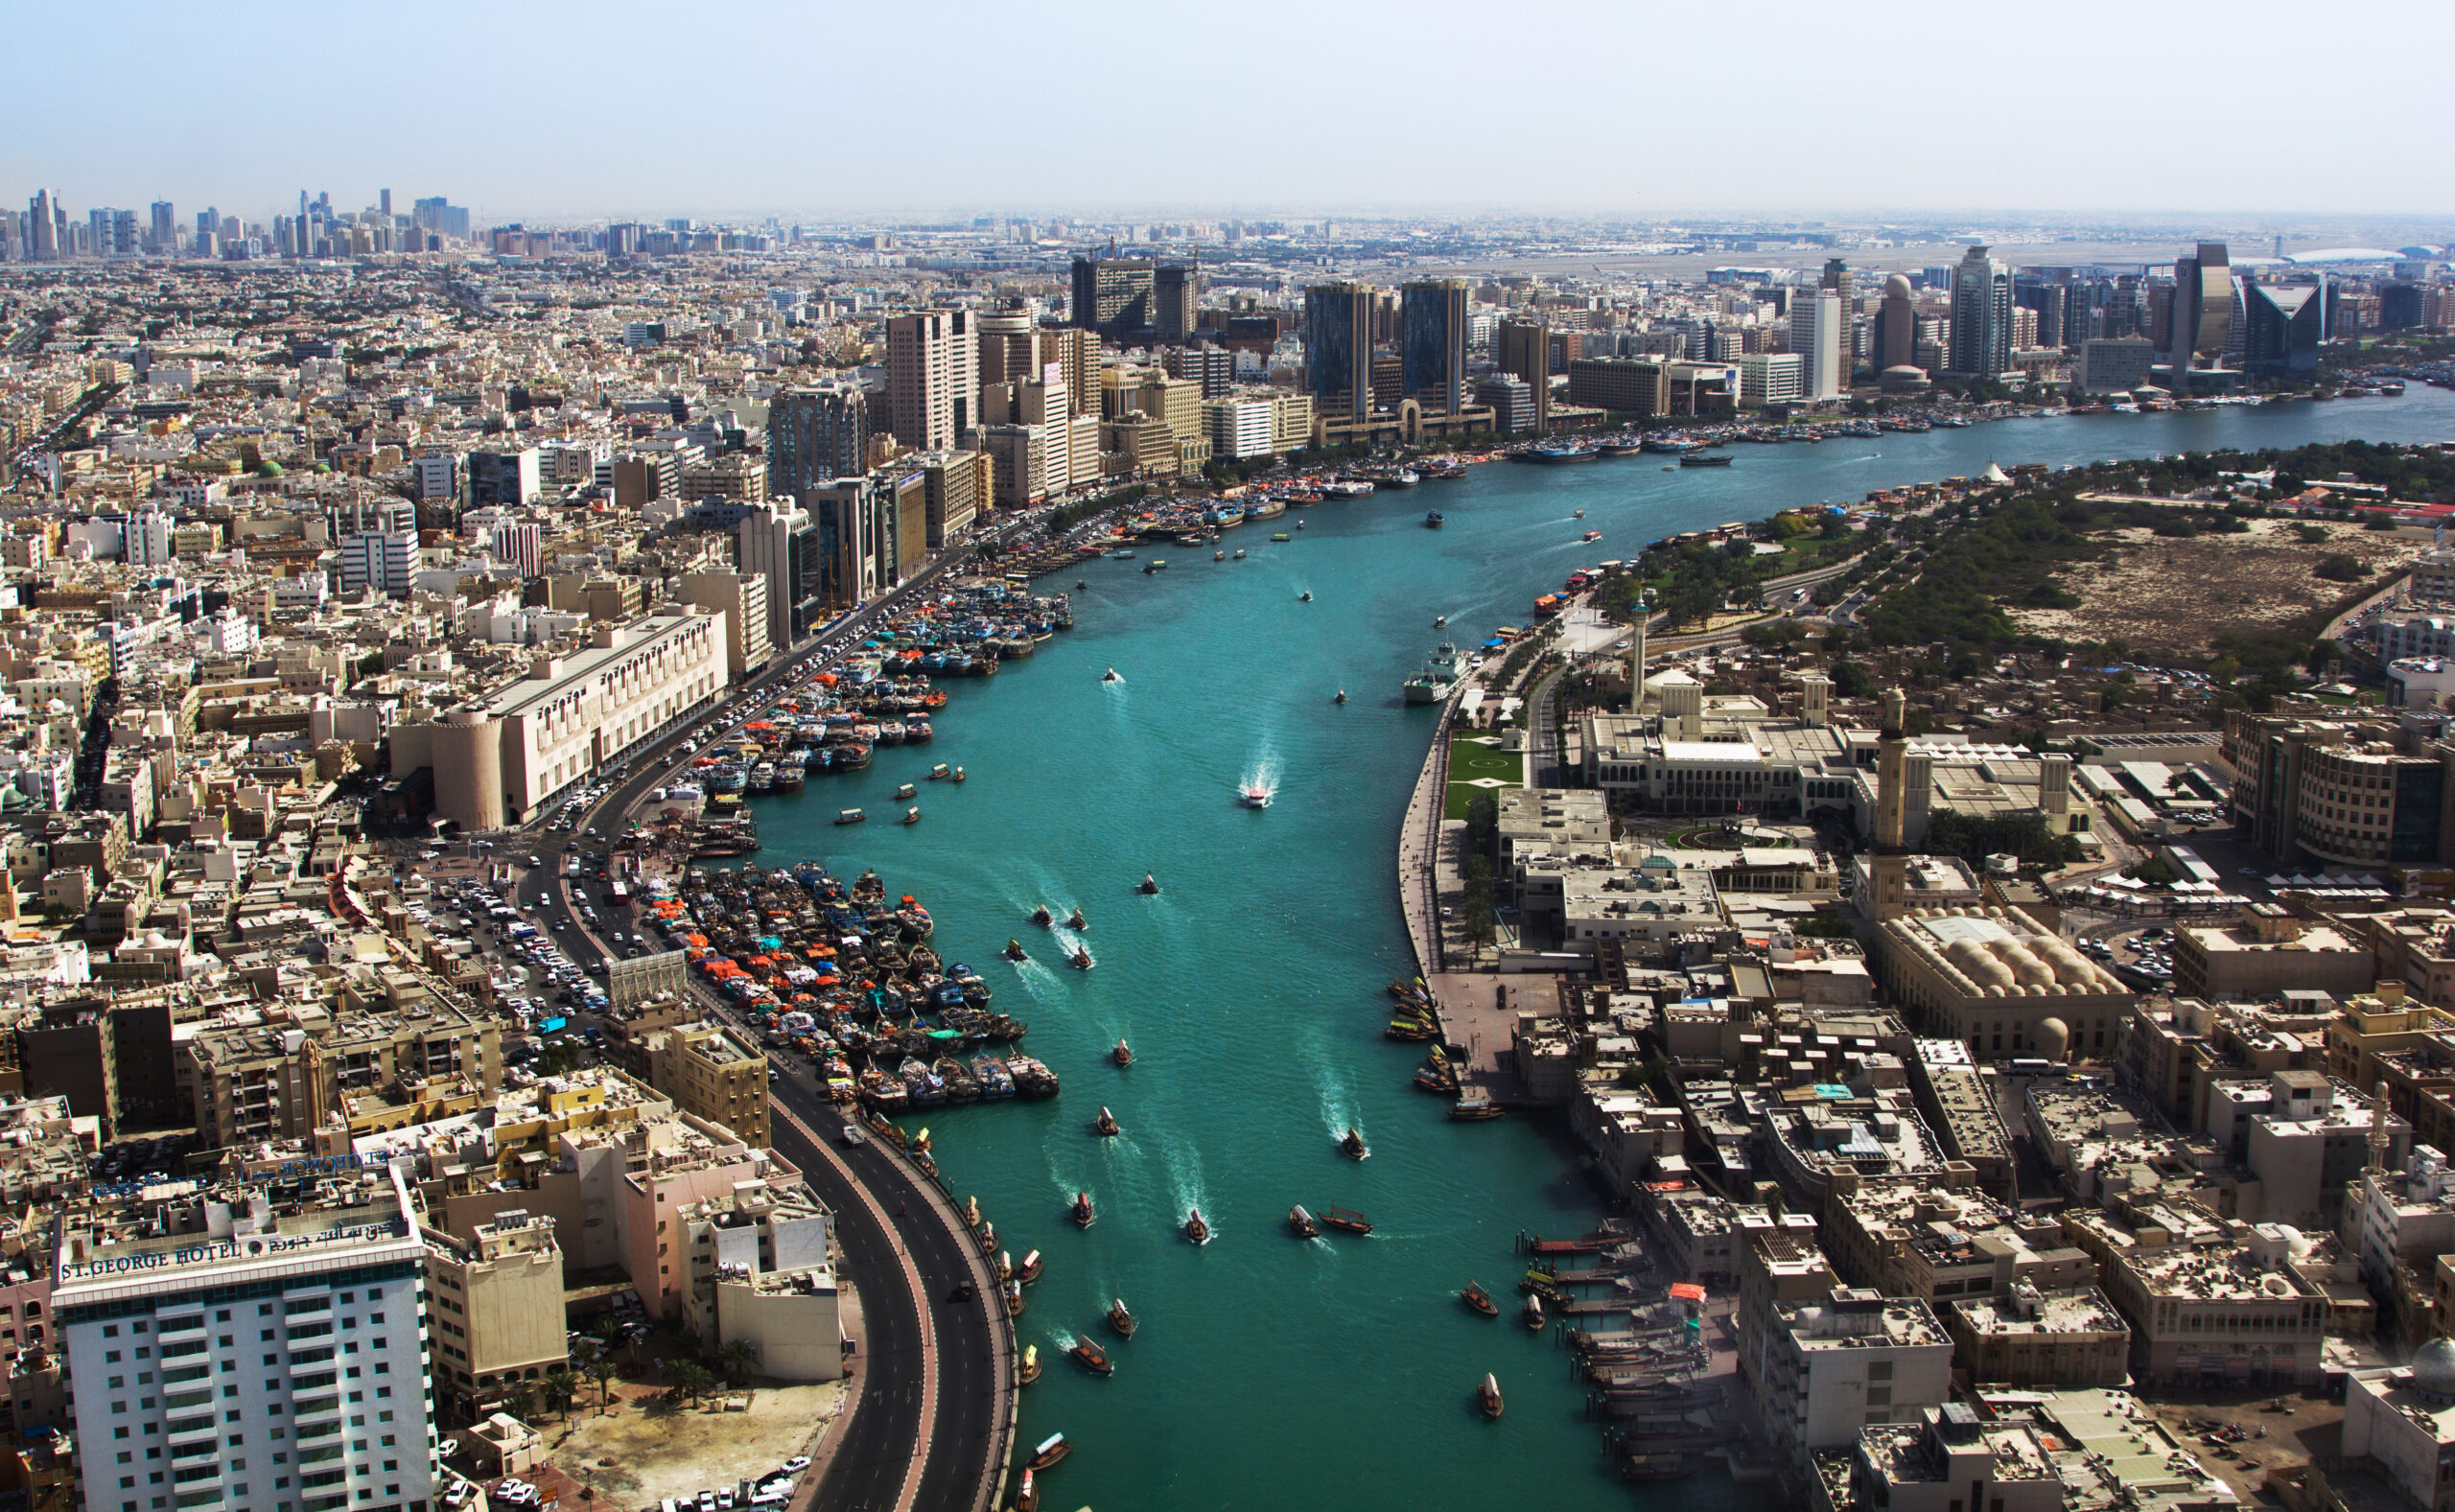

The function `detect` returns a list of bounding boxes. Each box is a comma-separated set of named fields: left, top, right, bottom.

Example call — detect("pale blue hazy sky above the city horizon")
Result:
left=19, top=0, right=2455, bottom=221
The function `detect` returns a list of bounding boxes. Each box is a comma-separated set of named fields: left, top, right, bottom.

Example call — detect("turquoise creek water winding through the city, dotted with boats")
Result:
left=759, top=387, right=2455, bottom=1512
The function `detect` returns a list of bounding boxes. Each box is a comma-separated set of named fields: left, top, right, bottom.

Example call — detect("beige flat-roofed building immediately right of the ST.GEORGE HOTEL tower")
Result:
left=420, top=1210, right=570, bottom=1421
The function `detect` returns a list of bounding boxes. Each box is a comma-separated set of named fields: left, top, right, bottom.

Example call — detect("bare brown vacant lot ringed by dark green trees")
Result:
left=2006, top=521, right=2413, bottom=658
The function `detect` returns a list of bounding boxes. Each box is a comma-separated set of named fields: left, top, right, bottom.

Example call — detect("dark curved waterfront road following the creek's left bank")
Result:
left=499, top=521, right=1026, bottom=1512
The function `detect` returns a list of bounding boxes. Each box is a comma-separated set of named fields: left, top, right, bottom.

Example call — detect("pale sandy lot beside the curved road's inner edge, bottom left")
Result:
left=530, top=1382, right=845, bottom=1507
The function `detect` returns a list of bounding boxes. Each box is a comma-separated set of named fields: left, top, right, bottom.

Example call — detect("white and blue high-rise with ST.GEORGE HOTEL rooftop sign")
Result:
left=52, top=1166, right=434, bottom=1512
